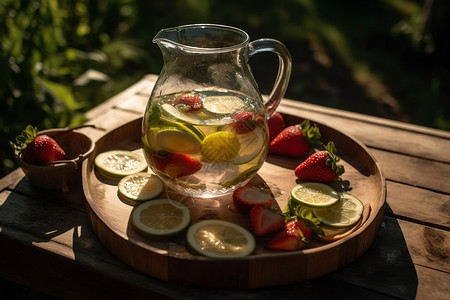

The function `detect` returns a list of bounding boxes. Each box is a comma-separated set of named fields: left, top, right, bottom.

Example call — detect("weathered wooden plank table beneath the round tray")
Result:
left=0, top=75, right=450, bottom=299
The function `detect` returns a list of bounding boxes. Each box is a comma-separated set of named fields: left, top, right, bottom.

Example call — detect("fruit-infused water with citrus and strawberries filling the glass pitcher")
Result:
left=142, top=90, right=268, bottom=197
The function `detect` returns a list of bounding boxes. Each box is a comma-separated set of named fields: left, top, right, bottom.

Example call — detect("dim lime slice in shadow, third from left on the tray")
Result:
left=131, top=199, right=191, bottom=237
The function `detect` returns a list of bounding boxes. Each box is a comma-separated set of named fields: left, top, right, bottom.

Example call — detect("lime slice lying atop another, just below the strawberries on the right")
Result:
left=291, top=182, right=339, bottom=208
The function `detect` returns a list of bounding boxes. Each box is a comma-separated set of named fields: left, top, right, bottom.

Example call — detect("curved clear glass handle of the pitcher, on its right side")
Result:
left=248, top=39, right=292, bottom=118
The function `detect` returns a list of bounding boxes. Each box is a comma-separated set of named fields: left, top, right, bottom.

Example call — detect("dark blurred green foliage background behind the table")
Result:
left=0, top=0, right=450, bottom=176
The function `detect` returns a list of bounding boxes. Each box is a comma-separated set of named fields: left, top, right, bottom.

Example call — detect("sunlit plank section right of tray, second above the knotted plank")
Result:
left=369, top=148, right=450, bottom=194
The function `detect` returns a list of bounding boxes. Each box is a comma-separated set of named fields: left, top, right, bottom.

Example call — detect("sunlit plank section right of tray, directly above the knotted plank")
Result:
left=385, top=181, right=450, bottom=230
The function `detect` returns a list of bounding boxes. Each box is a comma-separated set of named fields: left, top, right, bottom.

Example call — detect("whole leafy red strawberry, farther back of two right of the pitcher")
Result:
left=269, top=120, right=321, bottom=157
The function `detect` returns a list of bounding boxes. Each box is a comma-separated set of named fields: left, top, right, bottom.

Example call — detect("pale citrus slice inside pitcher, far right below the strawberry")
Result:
left=230, top=127, right=264, bottom=165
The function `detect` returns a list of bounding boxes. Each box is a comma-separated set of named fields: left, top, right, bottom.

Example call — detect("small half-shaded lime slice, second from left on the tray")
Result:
left=118, top=173, right=164, bottom=201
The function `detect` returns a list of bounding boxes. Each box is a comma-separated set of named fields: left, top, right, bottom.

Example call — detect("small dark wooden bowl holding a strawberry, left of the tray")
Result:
left=15, top=129, right=95, bottom=192
